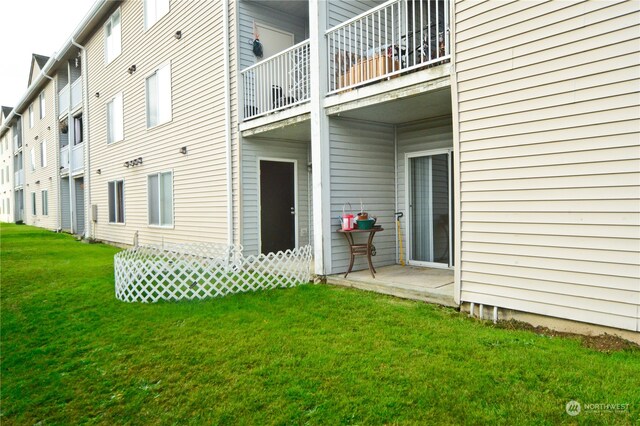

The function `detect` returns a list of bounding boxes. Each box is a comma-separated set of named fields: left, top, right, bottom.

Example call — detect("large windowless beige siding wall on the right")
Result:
left=455, top=1, right=640, bottom=331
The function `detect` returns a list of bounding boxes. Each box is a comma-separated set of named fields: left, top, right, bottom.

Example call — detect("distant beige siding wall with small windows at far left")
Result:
left=22, top=79, right=59, bottom=230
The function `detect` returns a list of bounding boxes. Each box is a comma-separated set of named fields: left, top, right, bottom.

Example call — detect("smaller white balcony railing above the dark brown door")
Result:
left=241, top=40, right=311, bottom=119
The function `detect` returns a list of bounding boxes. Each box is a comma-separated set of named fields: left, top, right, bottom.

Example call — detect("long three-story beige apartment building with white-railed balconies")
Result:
left=3, top=0, right=640, bottom=340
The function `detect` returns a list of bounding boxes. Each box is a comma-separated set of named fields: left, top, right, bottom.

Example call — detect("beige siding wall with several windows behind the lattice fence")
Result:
left=86, top=1, right=228, bottom=244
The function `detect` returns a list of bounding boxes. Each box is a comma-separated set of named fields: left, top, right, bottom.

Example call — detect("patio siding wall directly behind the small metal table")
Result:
left=329, top=117, right=396, bottom=274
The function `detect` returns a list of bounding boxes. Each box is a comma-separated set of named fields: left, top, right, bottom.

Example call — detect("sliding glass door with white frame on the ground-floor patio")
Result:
left=406, top=150, right=453, bottom=267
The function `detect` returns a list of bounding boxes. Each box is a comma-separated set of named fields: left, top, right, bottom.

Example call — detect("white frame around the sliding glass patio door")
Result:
left=404, top=148, right=454, bottom=270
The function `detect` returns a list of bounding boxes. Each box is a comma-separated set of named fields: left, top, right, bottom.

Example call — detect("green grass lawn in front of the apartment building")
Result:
left=0, top=225, right=640, bottom=425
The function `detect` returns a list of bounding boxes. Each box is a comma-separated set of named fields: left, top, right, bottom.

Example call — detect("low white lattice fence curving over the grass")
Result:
left=114, top=243, right=311, bottom=302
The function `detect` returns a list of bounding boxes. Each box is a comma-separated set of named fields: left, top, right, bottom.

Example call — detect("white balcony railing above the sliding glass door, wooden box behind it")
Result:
left=326, top=0, right=450, bottom=94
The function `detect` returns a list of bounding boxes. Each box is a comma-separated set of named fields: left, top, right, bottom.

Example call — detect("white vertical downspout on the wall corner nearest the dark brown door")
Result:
left=222, top=0, right=234, bottom=245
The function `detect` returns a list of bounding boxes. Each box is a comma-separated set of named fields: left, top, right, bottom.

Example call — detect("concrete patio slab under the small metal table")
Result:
left=327, top=265, right=458, bottom=307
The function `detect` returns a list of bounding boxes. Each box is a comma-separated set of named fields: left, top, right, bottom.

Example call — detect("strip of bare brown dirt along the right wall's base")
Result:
left=496, top=320, right=640, bottom=353
